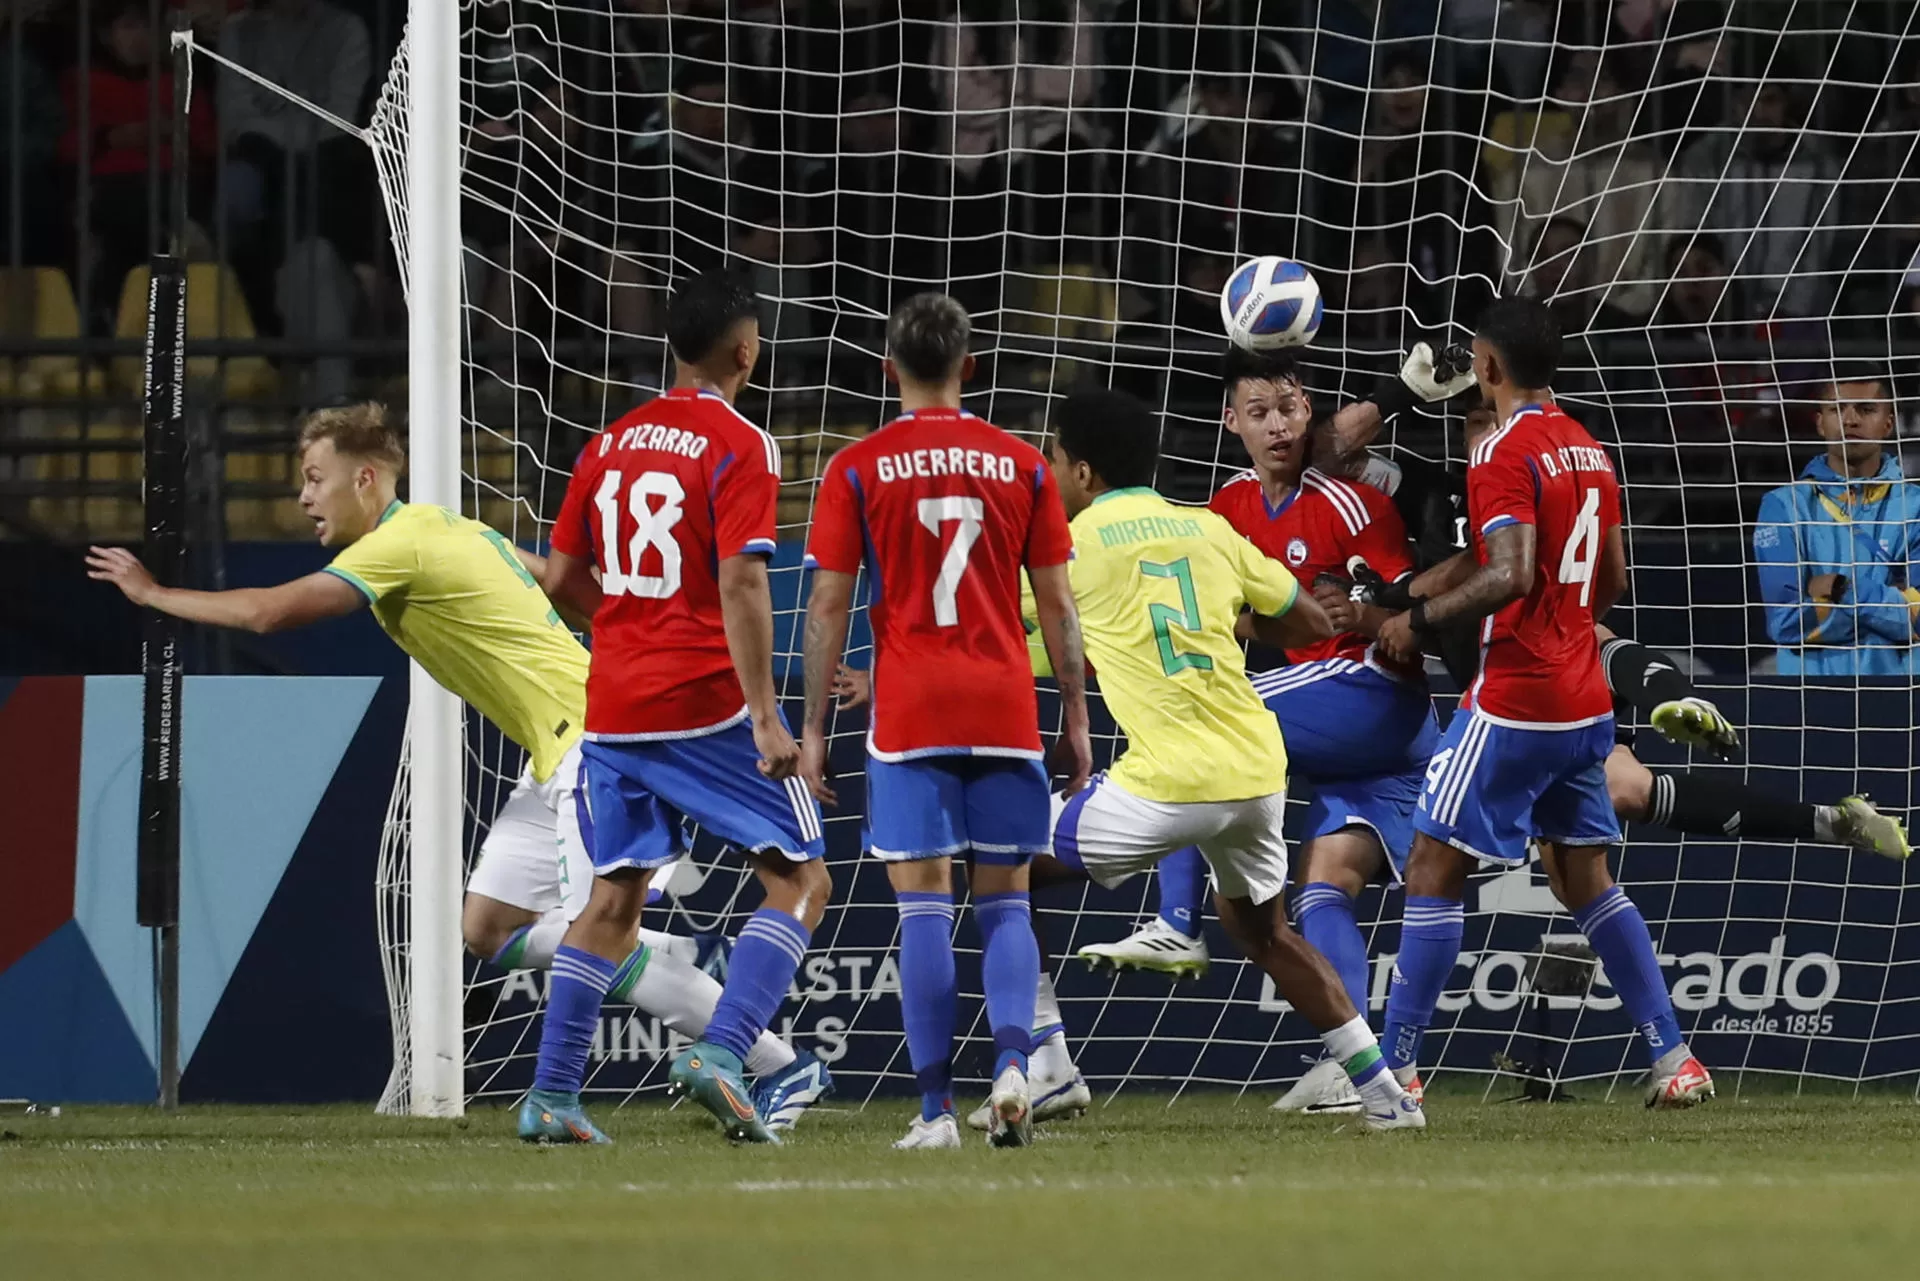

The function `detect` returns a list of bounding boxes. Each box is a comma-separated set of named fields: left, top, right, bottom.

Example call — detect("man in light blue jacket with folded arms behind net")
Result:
left=1753, top=375, right=1920, bottom=676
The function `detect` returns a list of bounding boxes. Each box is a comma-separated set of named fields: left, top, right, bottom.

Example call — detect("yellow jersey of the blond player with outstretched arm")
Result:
left=326, top=503, right=588, bottom=782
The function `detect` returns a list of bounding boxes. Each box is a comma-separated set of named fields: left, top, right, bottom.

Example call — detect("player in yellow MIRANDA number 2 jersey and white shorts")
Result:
left=1035, top=392, right=1425, bottom=1129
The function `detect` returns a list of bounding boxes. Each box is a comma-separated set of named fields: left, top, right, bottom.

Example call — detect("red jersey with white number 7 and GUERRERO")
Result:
left=806, top=409, right=1073, bottom=761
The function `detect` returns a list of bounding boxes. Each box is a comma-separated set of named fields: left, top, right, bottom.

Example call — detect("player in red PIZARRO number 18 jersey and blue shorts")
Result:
left=520, top=271, right=831, bottom=1143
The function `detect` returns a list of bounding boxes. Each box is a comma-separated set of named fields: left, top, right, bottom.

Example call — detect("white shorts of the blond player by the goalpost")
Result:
left=467, top=743, right=593, bottom=920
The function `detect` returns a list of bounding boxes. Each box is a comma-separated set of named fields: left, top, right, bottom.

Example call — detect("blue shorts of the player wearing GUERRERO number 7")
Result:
left=866, top=757, right=1052, bottom=866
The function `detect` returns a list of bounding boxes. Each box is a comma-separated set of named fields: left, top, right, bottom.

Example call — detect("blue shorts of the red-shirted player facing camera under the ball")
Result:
left=1254, top=659, right=1440, bottom=880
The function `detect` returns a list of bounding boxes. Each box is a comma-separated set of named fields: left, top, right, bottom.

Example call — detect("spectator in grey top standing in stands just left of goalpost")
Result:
left=219, top=0, right=378, bottom=405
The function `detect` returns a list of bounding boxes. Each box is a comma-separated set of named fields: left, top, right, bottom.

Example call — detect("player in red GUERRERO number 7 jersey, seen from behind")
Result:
left=801, top=294, right=1092, bottom=1148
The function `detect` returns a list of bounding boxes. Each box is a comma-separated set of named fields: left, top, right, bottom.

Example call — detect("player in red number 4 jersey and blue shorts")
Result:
left=1380, top=298, right=1713, bottom=1108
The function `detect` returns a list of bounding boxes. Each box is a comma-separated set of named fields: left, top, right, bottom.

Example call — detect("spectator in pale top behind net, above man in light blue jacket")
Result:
left=1661, top=83, right=1841, bottom=319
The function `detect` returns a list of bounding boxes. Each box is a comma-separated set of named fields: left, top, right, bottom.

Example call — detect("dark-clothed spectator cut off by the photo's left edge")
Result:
left=0, top=17, right=73, bottom=267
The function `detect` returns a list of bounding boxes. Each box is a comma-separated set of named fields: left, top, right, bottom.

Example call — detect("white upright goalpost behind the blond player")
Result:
left=403, top=0, right=465, bottom=1116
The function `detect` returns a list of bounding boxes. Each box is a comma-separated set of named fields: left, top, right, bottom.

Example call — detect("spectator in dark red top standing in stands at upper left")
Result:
left=60, top=0, right=217, bottom=332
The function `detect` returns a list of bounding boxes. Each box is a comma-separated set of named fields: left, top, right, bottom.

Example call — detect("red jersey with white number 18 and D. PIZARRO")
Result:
left=553, top=388, right=780, bottom=741
